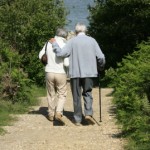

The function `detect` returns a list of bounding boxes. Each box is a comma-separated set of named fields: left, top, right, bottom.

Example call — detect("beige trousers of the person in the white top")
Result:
left=46, top=73, right=67, bottom=116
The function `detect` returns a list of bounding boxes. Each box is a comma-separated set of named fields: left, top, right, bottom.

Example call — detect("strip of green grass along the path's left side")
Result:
left=0, top=86, right=46, bottom=135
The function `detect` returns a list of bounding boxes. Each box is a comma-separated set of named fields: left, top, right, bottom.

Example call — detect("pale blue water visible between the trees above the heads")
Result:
left=64, top=0, right=94, bottom=31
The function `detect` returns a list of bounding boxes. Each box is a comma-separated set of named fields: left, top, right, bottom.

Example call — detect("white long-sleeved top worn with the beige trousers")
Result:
left=39, top=36, right=69, bottom=73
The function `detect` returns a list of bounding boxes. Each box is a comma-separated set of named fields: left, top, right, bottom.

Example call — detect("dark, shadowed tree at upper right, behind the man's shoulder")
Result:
left=89, top=0, right=150, bottom=69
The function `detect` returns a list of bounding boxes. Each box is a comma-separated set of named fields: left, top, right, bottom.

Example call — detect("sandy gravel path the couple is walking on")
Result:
left=0, top=83, right=124, bottom=150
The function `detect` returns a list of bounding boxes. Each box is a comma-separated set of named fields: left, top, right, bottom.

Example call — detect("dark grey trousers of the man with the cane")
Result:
left=71, top=78, right=93, bottom=123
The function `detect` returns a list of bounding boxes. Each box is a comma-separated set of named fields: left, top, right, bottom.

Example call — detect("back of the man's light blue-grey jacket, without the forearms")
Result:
left=67, top=33, right=103, bottom=78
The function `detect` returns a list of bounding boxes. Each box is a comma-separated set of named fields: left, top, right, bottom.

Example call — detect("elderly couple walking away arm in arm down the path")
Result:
left=39, top=23, right=105, bottom=126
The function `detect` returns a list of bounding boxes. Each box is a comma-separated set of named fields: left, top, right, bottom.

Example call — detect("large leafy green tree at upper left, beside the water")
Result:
left=0, top=0, right=66, bottom=84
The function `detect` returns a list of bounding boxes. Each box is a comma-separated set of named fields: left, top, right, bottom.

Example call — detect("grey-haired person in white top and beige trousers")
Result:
left=39, top=28, right=69, bottom=124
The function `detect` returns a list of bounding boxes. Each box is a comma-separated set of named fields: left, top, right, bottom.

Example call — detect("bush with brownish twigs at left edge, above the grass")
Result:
left=0, top=41, right=30, bottom=103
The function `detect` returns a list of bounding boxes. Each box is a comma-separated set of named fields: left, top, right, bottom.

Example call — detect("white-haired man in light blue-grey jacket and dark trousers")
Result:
left=50, top=23, right=105, bottom=125
